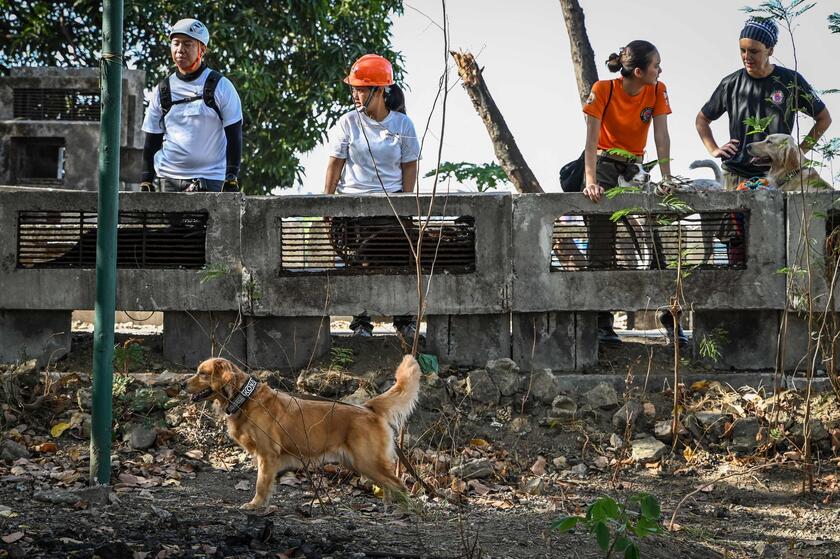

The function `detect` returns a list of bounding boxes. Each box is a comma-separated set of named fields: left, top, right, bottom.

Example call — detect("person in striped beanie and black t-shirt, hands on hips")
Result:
left=696, top=17, right=831, bottom=190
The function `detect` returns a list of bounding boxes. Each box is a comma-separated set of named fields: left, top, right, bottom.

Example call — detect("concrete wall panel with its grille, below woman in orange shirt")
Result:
left=513, top=192, right=785, bottom=312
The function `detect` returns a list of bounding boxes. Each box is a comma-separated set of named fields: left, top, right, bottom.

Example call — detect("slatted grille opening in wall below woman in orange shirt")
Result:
left=551, top=208, right=750, bottom=272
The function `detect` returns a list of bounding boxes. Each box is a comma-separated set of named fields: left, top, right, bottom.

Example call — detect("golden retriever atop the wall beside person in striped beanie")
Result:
left=747, top=134, right=830, bottom=192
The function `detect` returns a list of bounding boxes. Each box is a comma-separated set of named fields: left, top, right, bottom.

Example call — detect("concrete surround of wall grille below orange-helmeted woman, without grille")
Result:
left=242, top=194, right=511, bottom=316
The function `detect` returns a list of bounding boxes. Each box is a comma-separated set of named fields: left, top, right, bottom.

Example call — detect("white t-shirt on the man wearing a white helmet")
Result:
left=143, top=68, right=242, bottom=180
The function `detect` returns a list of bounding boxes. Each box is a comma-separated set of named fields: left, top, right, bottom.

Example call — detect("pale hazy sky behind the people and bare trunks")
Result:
left=292, top=0, right=840, bottom=194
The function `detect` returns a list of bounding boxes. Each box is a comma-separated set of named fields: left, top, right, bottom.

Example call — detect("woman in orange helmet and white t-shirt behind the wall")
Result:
left=324, top=54, right=420, bottom=343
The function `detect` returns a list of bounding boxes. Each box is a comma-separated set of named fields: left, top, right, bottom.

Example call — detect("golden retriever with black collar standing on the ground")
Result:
left=185, top=355, right=420, bottom=509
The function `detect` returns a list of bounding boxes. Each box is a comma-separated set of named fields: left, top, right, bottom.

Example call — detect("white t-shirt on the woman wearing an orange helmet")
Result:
left=330, top=110, right=420, bottom=194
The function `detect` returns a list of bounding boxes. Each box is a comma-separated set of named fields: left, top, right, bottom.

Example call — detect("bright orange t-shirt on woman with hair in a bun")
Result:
left=583, top=78, right=671, bottom=156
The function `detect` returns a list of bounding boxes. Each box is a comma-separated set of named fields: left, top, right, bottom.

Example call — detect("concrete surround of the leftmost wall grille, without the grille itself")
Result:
left=0, top=187, right=242, bottom=311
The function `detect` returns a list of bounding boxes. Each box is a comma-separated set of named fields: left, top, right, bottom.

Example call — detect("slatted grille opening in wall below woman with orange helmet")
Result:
left=279, top=215, right=475, bottom=274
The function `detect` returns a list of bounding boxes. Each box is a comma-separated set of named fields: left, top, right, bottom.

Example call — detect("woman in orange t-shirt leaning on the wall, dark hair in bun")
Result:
left=583, top=41, right=687, bottom=346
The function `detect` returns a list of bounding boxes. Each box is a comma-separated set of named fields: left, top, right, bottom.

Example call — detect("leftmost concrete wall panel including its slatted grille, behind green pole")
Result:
left=0, top=187, right=242, bottom=311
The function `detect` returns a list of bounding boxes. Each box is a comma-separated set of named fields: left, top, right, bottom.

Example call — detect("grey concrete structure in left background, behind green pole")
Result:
left=0, top=68, right=146, bottom=190
